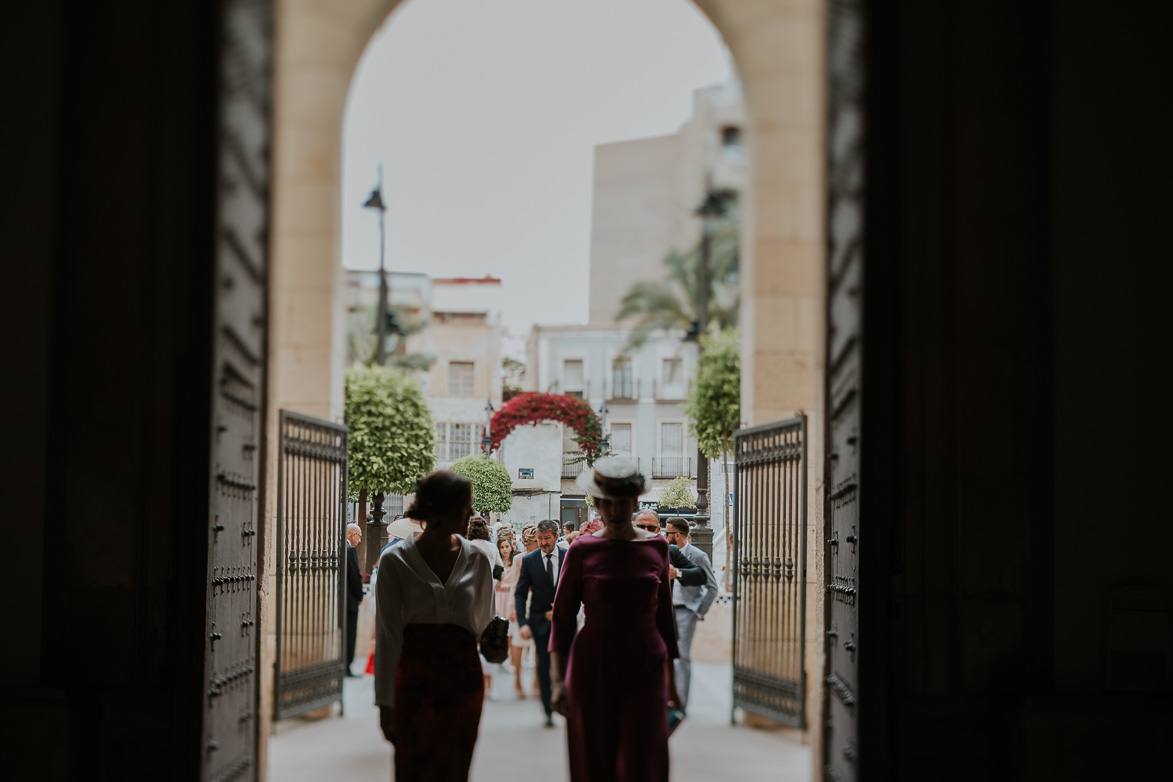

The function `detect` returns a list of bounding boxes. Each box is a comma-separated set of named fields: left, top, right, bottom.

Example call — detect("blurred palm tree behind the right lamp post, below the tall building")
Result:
left=616, top=205, right=740, bottom=355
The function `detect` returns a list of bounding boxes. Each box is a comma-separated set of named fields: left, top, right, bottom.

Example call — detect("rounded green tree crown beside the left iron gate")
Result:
left=346, top=367, right=435, bottom=501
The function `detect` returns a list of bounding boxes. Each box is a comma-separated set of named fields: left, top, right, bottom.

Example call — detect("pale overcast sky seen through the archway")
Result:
left=341, top=0, right=732, bottom=358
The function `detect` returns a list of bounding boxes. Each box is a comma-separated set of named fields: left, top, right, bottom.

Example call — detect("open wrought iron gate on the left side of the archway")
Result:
left=273, top=410, right=346, bottom=720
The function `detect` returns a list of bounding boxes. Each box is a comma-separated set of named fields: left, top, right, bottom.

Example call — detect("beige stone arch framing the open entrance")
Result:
left=266, top=0, right=826, bottom=776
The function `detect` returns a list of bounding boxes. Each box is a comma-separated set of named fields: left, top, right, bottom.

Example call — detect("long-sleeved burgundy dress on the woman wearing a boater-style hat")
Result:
left=550, top=536, right=679, bottom=782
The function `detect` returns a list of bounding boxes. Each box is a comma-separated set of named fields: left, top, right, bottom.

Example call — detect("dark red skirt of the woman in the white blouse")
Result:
left=394, top=625, right=484, bottom=782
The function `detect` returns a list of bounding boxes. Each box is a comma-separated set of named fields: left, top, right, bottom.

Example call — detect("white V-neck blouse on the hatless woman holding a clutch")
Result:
left=374, top=538, right=494, bottom=707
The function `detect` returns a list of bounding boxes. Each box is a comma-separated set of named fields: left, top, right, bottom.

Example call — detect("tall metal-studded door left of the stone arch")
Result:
left=201, top=0, right=272, bottom=782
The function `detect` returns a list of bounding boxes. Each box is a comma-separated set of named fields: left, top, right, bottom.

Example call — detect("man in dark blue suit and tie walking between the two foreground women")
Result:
left=514, top=519, right=567, bottom=728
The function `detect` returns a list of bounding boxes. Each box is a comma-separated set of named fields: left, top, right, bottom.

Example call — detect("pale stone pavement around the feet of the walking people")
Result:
left=269, top=662, right=811, bottom=782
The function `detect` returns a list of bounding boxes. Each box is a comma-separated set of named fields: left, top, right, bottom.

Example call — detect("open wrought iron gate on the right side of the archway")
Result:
left=733, top=416, right=807, bottom=727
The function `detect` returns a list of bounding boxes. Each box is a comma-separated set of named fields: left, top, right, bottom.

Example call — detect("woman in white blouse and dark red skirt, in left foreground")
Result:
left=374, top=471, right=494, bottom=782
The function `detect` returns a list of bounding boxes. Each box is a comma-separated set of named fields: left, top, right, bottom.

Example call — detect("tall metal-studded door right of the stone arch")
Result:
left=822, top=0, right=867, bottom=782
